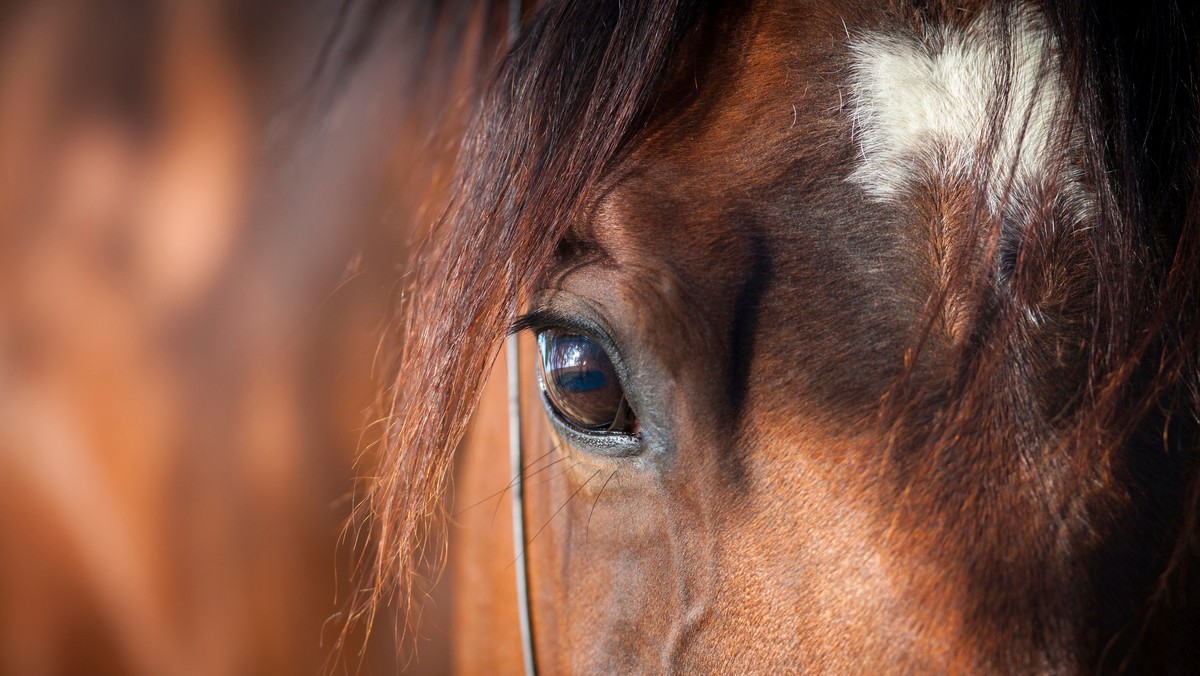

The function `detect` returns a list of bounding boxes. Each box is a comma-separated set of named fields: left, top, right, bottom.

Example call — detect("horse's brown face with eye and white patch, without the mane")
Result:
left=465, top=0, right=1186, bottom=671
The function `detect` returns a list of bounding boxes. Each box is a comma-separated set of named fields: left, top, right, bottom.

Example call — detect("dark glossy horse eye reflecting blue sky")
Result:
left=538, top=329, right=635, bottom=433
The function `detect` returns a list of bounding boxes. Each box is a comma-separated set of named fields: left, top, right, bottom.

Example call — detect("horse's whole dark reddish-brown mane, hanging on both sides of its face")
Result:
left=352, top=0, right=1200, bottom=662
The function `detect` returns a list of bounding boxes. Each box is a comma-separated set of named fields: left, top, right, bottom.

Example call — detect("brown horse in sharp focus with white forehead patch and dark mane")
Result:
left=360, top=0, right=1200, bottom=674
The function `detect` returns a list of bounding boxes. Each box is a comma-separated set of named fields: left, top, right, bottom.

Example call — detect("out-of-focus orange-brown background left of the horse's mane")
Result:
left=0, top=0, right=494, bottom=675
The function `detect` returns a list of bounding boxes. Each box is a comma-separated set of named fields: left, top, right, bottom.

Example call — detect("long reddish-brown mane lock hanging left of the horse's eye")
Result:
left=358, top=0, right=715, bottom=643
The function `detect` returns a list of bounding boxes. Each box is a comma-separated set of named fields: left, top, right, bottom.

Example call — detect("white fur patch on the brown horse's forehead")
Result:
left=851, top=7, right=1078, bottom=205
